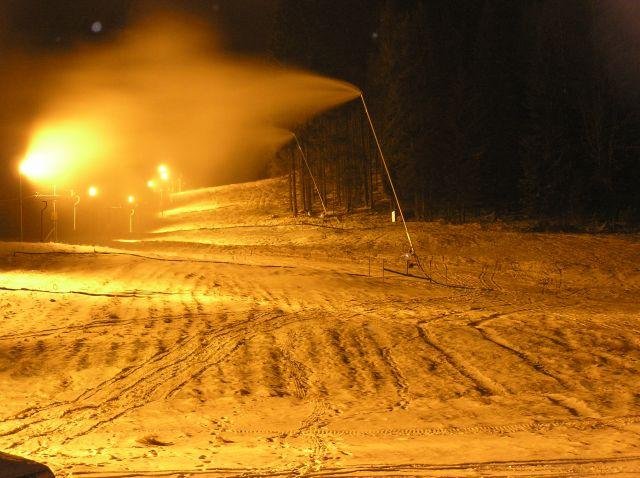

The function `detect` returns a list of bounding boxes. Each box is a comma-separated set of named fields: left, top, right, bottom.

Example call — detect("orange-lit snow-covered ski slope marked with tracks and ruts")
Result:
left=0, top=179, right=640, bottom=478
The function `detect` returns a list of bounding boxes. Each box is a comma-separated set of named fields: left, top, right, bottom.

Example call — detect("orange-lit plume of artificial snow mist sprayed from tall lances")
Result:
left=15, top=14, right=359, bottom=196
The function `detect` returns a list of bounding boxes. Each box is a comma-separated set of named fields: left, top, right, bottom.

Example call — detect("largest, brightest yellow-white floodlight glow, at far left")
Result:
left=20, top=121, right=104, bottom=183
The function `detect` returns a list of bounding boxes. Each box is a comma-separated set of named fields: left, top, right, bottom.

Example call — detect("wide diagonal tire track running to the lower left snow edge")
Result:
left=0, top=306, right=300, bottom=448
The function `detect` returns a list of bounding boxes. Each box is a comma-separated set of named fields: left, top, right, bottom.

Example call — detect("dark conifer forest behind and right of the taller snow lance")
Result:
left=273, top=0, right=640, bottom=228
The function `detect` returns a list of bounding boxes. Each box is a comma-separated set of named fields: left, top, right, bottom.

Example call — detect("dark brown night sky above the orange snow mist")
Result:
left=0, top=0, right=276, bottom=53
